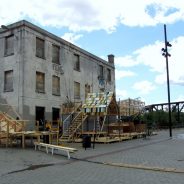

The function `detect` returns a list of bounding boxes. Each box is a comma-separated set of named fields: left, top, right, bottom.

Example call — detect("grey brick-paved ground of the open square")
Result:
left=0, top=129, right=184, bottom=184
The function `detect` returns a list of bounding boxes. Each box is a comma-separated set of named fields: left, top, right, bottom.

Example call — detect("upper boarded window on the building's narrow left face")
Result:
left=4, top=35, right=14, bottom=56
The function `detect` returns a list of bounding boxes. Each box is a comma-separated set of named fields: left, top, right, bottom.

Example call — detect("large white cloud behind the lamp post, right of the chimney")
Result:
left=115, top=36, right=184, bottom=85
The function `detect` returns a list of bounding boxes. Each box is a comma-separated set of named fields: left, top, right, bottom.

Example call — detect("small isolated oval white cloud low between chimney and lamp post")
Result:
left=132, top=81, right=156, bottom=94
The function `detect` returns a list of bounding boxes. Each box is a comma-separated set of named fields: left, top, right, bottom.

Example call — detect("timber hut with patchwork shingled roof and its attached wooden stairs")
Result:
left=61, top=92, right=119, bottom=141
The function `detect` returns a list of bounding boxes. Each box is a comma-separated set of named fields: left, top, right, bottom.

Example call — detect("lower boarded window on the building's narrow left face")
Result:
left=4, top=70, right=13, bottom=92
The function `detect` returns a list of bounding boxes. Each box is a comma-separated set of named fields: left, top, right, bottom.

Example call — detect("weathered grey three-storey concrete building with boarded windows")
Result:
left=0, top=20, right=115, bottom=129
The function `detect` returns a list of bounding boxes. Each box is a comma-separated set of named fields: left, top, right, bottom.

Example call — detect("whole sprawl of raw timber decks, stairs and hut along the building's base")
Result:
left=0, top=92, right=146, bottom=152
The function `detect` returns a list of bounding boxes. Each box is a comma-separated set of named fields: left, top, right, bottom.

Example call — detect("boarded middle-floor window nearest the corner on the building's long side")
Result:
left=36, top=72, right=45, bottom=93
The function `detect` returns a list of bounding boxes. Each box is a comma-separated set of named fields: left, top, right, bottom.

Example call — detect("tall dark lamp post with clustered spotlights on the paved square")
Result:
left=162, top=24, right=172, bottom=137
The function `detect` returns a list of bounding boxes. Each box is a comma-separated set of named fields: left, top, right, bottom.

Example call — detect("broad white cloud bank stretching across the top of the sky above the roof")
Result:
left=0, top=0, right=184, bottom=32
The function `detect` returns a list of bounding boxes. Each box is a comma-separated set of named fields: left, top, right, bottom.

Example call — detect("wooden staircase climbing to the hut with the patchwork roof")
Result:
left=60, top=111, right=87, bottom=142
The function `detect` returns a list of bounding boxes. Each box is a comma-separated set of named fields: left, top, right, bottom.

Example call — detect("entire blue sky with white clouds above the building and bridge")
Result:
left=0, top=0, right=184, bottom=104
